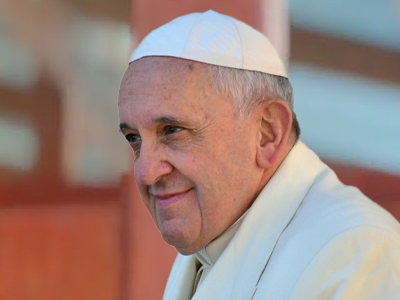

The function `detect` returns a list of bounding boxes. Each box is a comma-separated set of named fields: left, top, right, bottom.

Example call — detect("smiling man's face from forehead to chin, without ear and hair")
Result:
left=118, top=57, right=261, bottom=254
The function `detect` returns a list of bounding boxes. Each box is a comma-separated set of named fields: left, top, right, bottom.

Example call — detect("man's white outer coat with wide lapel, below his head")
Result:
left=164, top=141, right=400, bottom=300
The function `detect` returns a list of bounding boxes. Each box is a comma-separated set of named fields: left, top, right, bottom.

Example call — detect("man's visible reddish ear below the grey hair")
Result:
left=256, top=100, right=292, bottom=169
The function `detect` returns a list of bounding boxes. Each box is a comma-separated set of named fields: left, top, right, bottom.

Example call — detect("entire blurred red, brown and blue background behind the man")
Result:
left=0, top=0, right=400, bottom=300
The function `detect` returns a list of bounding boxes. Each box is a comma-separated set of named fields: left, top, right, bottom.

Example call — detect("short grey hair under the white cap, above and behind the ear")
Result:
left=207, top=65, right=300, bottom=141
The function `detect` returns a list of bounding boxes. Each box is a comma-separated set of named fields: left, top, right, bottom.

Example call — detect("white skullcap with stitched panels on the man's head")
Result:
left=130, top=10, right=287, bottom=77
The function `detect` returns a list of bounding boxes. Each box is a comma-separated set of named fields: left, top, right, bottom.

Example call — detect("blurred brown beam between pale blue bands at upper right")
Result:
left=290, top=27, right=400, bottom=85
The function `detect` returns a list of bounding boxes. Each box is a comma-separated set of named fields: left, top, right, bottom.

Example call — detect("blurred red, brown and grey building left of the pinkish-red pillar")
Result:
left=0, top=0, right=133, bottom=300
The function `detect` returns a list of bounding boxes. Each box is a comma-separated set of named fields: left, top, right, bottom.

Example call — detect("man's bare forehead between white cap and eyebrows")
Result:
left=118, top=57, right=216, bottom=126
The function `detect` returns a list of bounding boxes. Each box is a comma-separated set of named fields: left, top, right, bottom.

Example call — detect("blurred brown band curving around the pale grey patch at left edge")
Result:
left=0, top=77, right=62, bottom=186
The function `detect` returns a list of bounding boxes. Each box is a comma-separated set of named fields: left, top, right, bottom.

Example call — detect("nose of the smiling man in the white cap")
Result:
left=135, top=143, right=173, bottom=186
